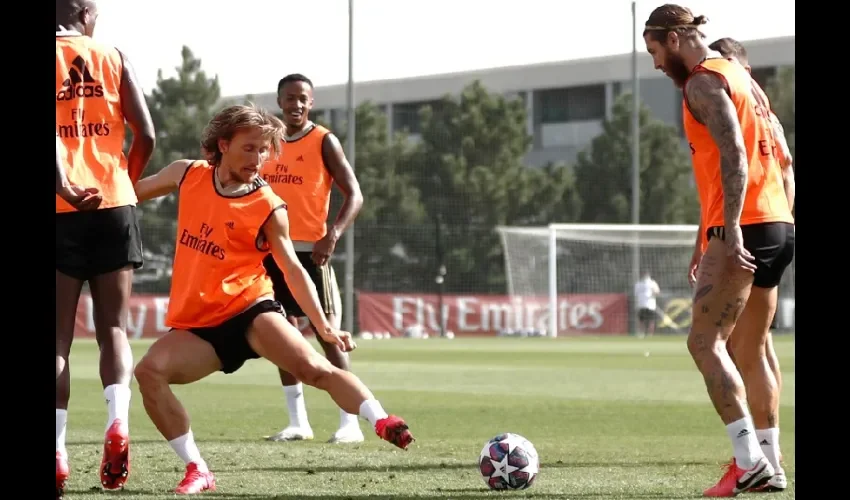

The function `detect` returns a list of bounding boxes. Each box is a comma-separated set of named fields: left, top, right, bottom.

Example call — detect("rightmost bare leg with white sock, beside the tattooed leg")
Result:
left=732, top=287, right=787, bottom=490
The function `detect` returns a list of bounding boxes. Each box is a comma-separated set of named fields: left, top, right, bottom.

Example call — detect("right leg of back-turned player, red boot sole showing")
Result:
left=89, top=266, right=133, bottom=490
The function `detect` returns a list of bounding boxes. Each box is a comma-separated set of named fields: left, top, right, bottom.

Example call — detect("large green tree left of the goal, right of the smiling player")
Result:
left=410, top=81, right=577, bottom=293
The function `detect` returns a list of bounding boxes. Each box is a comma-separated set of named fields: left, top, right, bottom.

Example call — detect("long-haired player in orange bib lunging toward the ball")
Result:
left=135, top=106, right=413, bottom=494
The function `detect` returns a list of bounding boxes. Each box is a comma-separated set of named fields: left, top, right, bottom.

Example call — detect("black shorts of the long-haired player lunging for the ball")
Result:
left=188, top=300, right=283, bottom=373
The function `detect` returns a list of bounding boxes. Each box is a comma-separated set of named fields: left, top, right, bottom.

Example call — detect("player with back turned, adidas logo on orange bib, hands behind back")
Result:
left=56, top=0, right=154, bottom=496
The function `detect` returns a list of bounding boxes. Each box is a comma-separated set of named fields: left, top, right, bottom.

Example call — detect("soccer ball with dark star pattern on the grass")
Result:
left=478, top=433, right=540, bottom=490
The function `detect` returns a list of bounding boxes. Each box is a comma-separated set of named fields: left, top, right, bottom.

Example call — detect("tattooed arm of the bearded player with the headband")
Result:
left=685, top=71, right=748, bottom=227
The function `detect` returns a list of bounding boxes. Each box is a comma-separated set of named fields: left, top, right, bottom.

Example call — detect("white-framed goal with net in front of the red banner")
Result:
left=497, top=224, right=794, bottom=336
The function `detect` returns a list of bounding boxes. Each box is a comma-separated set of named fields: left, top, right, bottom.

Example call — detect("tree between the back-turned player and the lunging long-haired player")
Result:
left=137, top=46, right=221, bottom=292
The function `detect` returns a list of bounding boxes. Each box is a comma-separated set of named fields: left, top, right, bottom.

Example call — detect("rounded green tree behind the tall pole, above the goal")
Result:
left=575, top=94, right=699, bottom=224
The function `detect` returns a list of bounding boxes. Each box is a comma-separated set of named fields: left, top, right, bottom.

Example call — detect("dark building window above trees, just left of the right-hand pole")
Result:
left=535, top=84, right=605, bottom=123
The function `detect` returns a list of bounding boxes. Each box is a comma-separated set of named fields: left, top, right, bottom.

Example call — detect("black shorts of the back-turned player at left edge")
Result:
left=56, top=205, right=144, bottom=281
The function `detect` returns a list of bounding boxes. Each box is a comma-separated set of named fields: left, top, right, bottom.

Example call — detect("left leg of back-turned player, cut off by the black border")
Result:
left=56, top=271, right=83, bottom=498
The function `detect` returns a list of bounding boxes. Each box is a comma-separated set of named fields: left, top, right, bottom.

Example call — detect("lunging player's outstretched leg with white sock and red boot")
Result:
left=248, top=313, right=413, bottom=449
